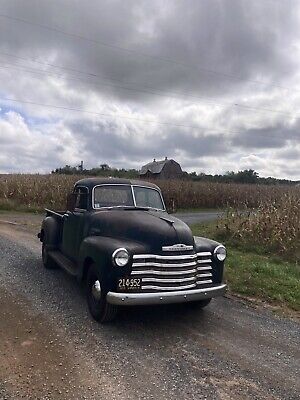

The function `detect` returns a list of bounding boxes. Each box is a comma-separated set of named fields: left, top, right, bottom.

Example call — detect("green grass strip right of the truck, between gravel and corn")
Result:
left=192, top=222, right=300, bottom=312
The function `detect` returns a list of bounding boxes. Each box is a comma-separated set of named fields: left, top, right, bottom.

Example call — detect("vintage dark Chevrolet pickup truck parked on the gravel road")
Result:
left=38, top=178, right=226, bottom=322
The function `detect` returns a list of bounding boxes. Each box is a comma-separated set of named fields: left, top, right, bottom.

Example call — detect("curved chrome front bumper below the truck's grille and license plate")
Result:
left=106, top=284, right=227, bottom=306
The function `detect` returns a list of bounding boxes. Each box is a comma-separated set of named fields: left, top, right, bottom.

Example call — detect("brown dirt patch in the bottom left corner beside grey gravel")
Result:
left=0, top=287, right=112, bottom=399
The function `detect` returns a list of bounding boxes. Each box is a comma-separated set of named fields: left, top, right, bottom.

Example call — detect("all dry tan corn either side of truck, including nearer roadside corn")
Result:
left=0, top=174, right=300, bottom=260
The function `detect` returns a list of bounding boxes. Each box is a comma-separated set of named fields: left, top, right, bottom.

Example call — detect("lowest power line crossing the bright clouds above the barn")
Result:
left=0, top=97, right=298, bottom=140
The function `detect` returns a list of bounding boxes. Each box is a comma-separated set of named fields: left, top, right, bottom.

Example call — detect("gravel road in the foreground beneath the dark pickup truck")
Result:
left=0, top=216, right=300, bottom=400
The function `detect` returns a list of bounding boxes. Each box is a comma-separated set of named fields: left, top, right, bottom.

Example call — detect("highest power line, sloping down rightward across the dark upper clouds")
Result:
left=0, top=14, right=297, bottom=91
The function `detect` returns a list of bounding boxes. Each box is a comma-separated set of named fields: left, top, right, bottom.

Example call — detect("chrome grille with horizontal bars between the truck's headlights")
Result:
left=131, top=251, right=212, bottom=291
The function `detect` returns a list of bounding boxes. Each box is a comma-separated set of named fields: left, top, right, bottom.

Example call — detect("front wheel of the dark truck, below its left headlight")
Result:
left=86, top=264, right=118, bottom=322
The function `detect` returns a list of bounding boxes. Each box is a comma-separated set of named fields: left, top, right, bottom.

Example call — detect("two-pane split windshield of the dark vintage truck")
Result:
left=93, top=185, right=165, bottom=210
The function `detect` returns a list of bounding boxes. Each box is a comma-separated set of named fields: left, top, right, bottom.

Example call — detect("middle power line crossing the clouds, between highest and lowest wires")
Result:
left=0, top=58, right=299, bottom=117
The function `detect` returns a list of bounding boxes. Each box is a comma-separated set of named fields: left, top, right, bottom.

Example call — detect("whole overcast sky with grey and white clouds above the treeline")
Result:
left=0, top=0, right=300, bottom=179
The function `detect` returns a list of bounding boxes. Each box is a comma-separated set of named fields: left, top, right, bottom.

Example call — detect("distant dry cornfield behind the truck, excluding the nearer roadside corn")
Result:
left=0, top=174, right=299, bottom=210
